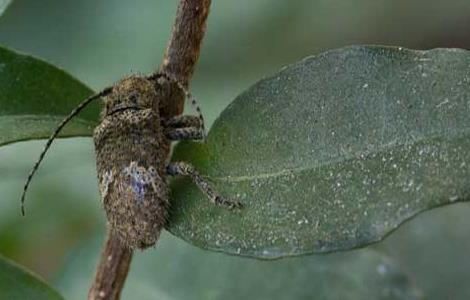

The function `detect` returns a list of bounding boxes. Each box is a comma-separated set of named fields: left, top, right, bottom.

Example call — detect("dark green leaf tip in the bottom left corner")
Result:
left=0, top=256, right=63, bottom=300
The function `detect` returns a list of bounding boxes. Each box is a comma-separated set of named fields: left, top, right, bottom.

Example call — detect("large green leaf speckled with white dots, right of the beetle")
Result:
left=168, top=46, right=470, bottom=258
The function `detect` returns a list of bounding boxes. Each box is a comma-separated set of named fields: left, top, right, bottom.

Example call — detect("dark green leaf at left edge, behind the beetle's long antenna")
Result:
left=0, top=47, right=99, bottom=146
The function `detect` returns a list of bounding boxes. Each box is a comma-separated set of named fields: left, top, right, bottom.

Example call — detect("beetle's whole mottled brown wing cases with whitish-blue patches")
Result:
left=94, top=109, right=169, bottom=249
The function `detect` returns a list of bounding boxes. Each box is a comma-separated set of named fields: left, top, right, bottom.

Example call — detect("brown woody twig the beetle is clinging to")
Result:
left=88, top=0, right=211, bottom=300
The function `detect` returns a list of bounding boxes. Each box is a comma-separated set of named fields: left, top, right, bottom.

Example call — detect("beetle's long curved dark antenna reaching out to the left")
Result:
left=21, top=87, right=112, bottom=216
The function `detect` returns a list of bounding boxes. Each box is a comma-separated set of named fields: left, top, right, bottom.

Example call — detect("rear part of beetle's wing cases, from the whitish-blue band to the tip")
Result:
left=100, top=161, right=168, bottom=249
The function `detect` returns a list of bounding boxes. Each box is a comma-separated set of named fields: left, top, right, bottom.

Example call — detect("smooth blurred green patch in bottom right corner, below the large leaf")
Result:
left=377, top=203, right=470, bottom=300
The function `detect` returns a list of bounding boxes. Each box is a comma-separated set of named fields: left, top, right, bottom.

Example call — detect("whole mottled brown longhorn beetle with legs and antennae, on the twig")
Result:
left=21, top=73, right=242, bottom=249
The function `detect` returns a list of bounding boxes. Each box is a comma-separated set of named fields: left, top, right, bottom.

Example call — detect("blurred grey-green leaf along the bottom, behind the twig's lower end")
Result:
left=55, top=234, right=422, bottom=300
